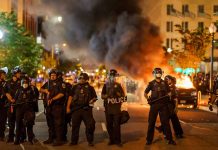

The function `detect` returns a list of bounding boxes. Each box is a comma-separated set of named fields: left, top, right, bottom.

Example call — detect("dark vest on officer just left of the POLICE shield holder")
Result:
left=73, top=84, right=90, bottom=105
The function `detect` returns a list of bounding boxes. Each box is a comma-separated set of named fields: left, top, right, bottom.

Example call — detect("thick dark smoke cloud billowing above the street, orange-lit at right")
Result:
left=36, top=0, right=169, bottom=79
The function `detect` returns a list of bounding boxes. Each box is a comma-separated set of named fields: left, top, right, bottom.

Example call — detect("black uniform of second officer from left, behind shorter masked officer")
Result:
left=6, top=79, right=21, bottom=142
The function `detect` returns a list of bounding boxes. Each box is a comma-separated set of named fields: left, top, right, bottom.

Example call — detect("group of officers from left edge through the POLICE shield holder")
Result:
left=0, top=67, right=125, bottom=146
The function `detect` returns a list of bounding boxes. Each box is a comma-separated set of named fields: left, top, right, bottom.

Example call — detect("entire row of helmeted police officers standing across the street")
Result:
left=0, top=67, right=183, bottom=146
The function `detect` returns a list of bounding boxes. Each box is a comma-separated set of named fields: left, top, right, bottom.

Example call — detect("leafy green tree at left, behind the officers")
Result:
left=0, top=12, right=43, bottom=76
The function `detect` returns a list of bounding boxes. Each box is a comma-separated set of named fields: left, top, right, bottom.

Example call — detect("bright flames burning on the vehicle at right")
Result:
left=176, top=75, right=194, bottom=89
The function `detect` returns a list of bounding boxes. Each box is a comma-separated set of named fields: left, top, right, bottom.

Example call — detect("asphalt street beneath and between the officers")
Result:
left=0, top=96, right=218, bottom=150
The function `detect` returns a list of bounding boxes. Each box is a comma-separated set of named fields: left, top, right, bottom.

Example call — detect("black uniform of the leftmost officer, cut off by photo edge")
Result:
left=0, top=81, right=7, bottom=141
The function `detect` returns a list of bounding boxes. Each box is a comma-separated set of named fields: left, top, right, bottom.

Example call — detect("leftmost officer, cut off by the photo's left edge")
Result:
left=0, top=67, right=7, bottom=141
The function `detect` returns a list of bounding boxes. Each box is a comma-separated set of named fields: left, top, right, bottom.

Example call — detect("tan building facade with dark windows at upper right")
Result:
left=144, top=0, right=218, bottom=73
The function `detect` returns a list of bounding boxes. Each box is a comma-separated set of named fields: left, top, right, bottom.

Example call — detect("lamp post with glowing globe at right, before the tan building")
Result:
left=209, top=23, right=217, bottom=91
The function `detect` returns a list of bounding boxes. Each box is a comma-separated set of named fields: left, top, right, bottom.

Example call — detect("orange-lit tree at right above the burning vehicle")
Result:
left=170, top=25, right=211, bottom=69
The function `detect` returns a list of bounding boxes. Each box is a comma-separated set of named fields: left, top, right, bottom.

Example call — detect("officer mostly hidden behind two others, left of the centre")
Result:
left=57, top=71, right=72, bottom=142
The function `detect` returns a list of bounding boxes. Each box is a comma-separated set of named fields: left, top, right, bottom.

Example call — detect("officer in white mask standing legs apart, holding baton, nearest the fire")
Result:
left=144, top=68, right=176, bottom=145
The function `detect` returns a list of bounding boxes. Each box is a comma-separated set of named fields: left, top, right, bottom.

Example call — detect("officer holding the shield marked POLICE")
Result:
left=101, top=69, right=125, bottom=146
